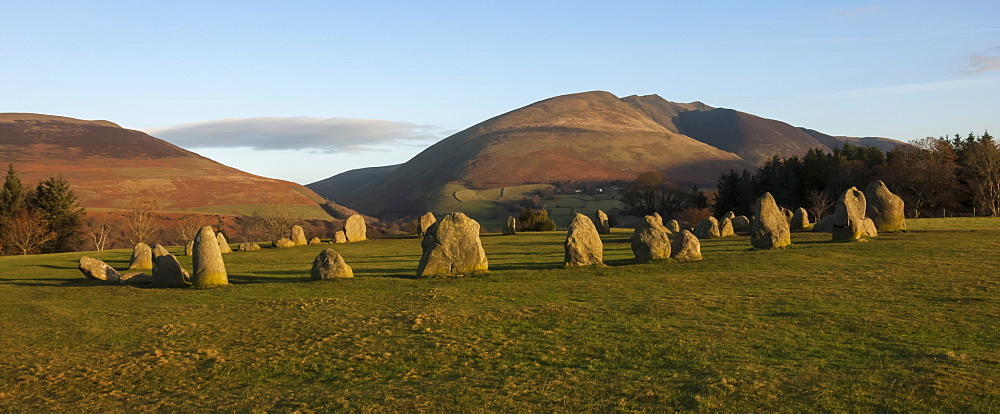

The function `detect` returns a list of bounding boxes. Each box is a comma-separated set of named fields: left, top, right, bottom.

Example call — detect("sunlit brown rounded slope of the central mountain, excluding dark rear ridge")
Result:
left=309, top=92, right=752, bottom=215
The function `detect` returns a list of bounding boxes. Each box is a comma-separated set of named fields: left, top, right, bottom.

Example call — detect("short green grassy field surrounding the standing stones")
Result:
left=0, top=218, right=1000, bottom=412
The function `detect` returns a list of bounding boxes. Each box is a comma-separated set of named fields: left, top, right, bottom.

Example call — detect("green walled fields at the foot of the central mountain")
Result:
left=427, top=184, right=623, bottom=230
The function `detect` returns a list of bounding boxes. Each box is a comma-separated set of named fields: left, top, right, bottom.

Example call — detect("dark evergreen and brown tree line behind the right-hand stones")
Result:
left=713, top=132, right=1000, bottom=217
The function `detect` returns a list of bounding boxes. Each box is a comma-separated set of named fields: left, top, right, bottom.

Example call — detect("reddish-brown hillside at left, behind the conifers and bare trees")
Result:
left=0, top=113, right=329, bottom=218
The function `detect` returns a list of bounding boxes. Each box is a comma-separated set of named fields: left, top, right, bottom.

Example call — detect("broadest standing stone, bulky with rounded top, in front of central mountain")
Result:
left=417, top=213, right=489, bottom=277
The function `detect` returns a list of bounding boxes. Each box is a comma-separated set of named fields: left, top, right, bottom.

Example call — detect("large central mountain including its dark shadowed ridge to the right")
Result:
left=307, top=91, right=901, bottom=215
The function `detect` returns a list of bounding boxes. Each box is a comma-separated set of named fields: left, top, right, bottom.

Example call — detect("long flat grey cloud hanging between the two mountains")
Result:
left=144, top=117, right=447, bottom=153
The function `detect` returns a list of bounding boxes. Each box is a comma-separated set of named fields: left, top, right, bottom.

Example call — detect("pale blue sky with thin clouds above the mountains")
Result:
left=0, top=0, right=1000, bottom=184
